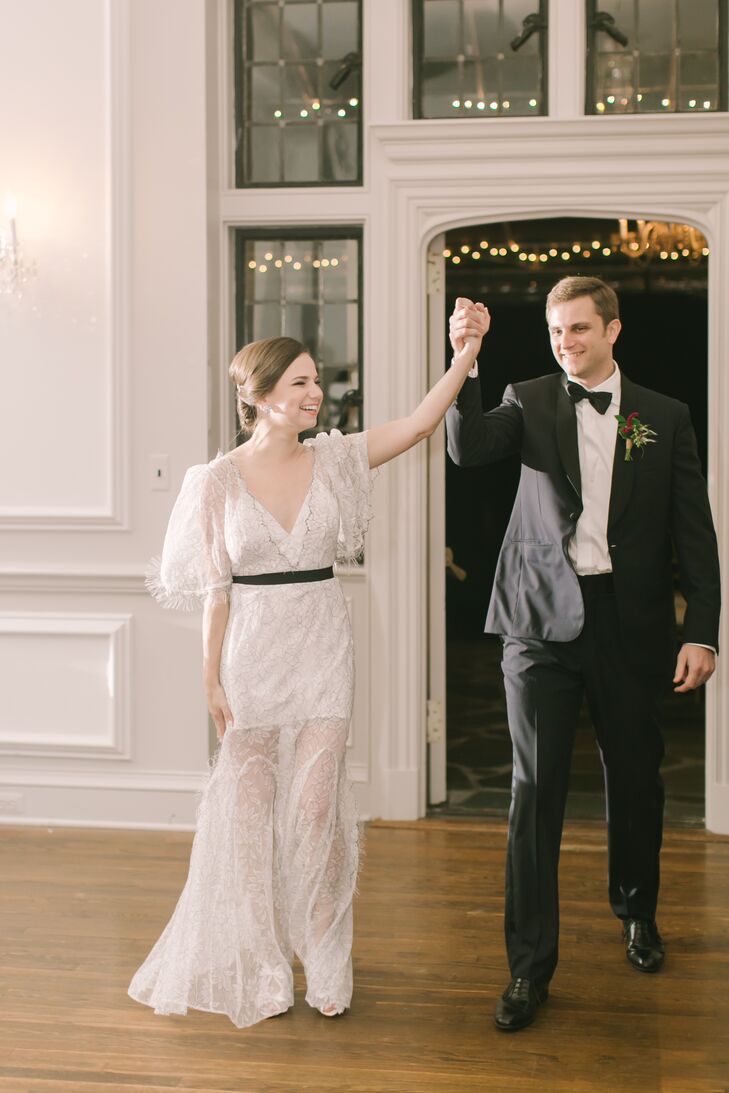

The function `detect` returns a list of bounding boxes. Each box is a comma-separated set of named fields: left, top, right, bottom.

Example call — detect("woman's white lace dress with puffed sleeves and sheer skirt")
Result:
left=129, top=431, right=372, bottom=1027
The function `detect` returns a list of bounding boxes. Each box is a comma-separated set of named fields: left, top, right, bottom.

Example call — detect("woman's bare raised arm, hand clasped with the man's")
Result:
left=367, top=299, right=491, bottom=468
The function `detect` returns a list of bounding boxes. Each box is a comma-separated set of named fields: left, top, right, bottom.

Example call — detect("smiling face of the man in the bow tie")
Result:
left=548, top=296, right=620, bottom=386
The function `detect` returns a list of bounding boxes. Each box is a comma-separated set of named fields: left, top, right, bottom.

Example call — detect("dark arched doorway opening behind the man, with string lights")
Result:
left=444, top=218, right=708, bottom=826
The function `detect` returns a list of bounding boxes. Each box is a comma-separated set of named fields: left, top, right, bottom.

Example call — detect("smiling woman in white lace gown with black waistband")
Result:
left=129, top=308, right=490, bottom=1027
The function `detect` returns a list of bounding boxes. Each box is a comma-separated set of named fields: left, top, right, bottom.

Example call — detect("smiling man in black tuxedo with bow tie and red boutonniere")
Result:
left=446, top=277, right=719, bottom=1032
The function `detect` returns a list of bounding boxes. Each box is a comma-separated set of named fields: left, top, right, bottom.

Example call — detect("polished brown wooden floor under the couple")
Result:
left=0, top=821, right=729, bottom=1093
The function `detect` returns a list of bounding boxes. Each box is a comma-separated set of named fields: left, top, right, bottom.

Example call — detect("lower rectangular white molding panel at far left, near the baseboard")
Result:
left=0, top=611, right=132, bottom=760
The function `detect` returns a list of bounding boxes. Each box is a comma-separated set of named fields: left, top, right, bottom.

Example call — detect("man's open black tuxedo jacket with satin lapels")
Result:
left=446, top=374, right=720, bottom=674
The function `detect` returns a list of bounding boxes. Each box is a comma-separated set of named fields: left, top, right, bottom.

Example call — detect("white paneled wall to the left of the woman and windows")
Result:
left=0, top=0, right=209, bottom=825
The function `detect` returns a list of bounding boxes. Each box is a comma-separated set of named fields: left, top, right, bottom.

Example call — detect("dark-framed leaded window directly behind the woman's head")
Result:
left=235, top=226, right=363, bottom=433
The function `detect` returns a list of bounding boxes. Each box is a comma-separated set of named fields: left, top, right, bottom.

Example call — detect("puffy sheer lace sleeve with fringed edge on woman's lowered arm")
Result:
left=145, top=463, right=232, bottom=611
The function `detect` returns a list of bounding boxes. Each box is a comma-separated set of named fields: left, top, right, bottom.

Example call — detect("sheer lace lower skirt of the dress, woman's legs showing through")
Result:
left=129, top=719, right=358, bottom=1027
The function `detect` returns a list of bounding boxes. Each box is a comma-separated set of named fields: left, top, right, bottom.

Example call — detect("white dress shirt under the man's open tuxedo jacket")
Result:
left=569, top=362, right=621, bottom=577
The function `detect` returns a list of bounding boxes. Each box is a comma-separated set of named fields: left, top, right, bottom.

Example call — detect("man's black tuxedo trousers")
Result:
left=502, top=575, right=667, bottom=980
